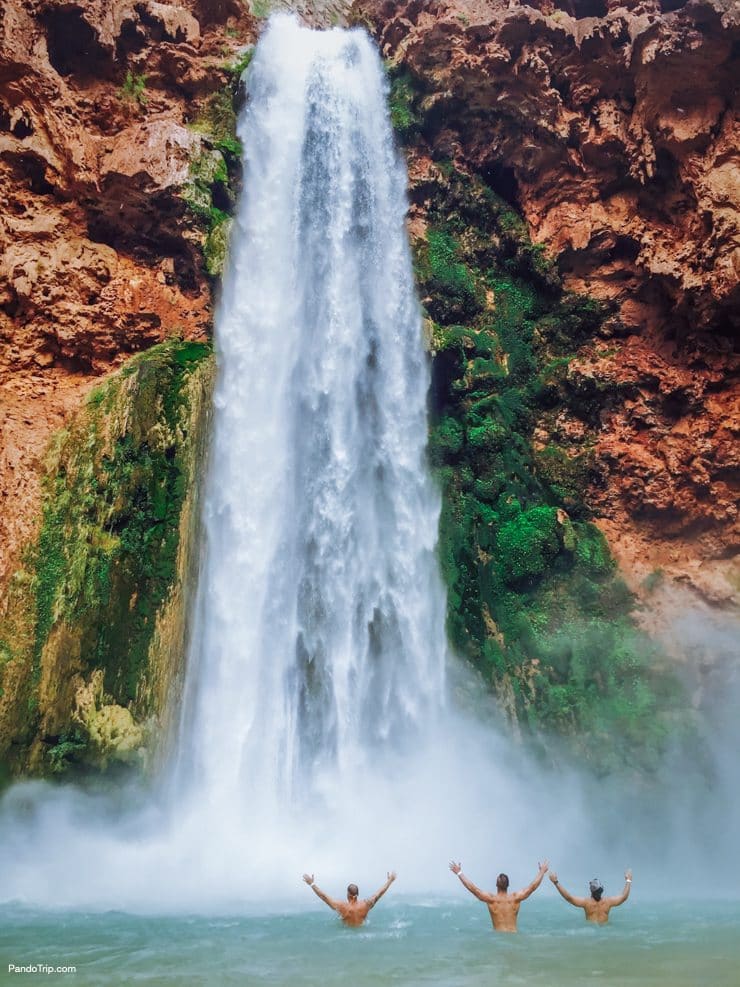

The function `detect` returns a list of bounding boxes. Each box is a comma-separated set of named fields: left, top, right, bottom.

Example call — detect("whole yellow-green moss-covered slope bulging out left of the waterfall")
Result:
left=0, top=340, right=213, bottom=773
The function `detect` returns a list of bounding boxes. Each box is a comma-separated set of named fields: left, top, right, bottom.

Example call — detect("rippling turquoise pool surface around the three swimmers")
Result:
left=0, top=904, right=740, bottom=987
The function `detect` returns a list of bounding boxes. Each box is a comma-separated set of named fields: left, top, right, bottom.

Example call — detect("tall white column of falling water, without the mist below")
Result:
left=176, top=16, right=445, bottom=811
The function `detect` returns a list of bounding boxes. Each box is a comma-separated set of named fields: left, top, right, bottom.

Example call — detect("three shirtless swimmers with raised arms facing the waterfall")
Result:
left=303, top=860, right=632, bottom=932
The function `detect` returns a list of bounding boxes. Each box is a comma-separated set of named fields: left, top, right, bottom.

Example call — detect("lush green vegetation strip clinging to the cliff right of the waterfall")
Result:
left=417, top=167, right=679, bottom=772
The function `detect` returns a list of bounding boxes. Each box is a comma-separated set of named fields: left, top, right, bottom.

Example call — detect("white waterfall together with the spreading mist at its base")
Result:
left=0, top=16, right=738, bottom=913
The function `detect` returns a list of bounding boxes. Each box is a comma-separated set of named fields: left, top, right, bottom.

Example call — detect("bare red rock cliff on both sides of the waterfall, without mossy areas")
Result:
left=0, top=0, right=740, bottom=632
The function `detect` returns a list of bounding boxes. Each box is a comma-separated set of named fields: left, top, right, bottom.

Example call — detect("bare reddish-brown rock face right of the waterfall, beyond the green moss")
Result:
left=354, top=0, right=740, bottom=604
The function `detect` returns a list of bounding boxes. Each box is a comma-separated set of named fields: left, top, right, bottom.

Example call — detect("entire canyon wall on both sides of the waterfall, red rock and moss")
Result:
left=0, top=0, right=740, bottom=773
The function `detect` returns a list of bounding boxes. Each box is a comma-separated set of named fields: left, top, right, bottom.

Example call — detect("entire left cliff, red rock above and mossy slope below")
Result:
left=0, top=0, right=256, bottom=773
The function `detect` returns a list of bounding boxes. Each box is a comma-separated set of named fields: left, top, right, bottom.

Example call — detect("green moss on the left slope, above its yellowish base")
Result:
left=34, top=341, right=210, bottom=706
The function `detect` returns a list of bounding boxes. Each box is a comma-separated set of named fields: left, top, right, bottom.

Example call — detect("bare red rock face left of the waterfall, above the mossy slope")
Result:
left=0, top=0, right=254, bottom=586
